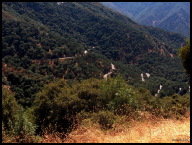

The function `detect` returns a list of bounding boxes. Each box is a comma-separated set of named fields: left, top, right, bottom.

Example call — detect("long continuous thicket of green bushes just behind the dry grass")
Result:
left=31, top=76, right=190, bottom=132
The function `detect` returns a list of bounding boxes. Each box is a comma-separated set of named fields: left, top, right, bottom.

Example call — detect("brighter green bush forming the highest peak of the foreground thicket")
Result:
left=99, top=76, right=142, bottom=114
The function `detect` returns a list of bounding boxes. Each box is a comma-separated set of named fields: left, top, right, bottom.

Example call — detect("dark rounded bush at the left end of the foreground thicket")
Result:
left=34, top=81, right=81, bottom=133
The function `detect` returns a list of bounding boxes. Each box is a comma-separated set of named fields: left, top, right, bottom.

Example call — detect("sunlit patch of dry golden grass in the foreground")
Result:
left=64, top=118, right=190, bottom=143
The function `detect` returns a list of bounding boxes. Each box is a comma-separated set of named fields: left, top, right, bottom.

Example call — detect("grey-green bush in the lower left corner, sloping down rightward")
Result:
left=2, top=88, right=36, bottom=142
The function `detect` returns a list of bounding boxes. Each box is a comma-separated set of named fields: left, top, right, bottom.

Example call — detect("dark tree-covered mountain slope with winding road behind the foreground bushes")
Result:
left=2, top=2, right=186, bottom=105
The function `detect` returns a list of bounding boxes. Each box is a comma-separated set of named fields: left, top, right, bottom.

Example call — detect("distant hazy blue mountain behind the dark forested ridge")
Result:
left=103, top=2, right=190, bottom=37
